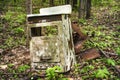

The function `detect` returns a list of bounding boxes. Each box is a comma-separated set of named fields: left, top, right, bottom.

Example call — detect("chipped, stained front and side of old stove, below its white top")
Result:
left=28, top=14, right=76, bottom=72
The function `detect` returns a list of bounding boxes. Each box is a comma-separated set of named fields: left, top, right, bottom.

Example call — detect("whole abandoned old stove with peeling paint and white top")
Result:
left=27, top=5, right=76, bottom=72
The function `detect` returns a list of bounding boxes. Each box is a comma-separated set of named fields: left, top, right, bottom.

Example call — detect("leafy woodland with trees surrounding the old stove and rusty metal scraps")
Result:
left=0, top=0, right=120, bottom=80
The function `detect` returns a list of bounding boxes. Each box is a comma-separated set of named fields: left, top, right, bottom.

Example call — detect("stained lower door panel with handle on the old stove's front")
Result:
left=30, top=36, right=62, bottom=63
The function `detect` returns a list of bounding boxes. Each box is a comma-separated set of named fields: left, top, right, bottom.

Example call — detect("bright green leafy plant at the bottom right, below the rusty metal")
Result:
left=93, top=67, right=110, bottom=79
